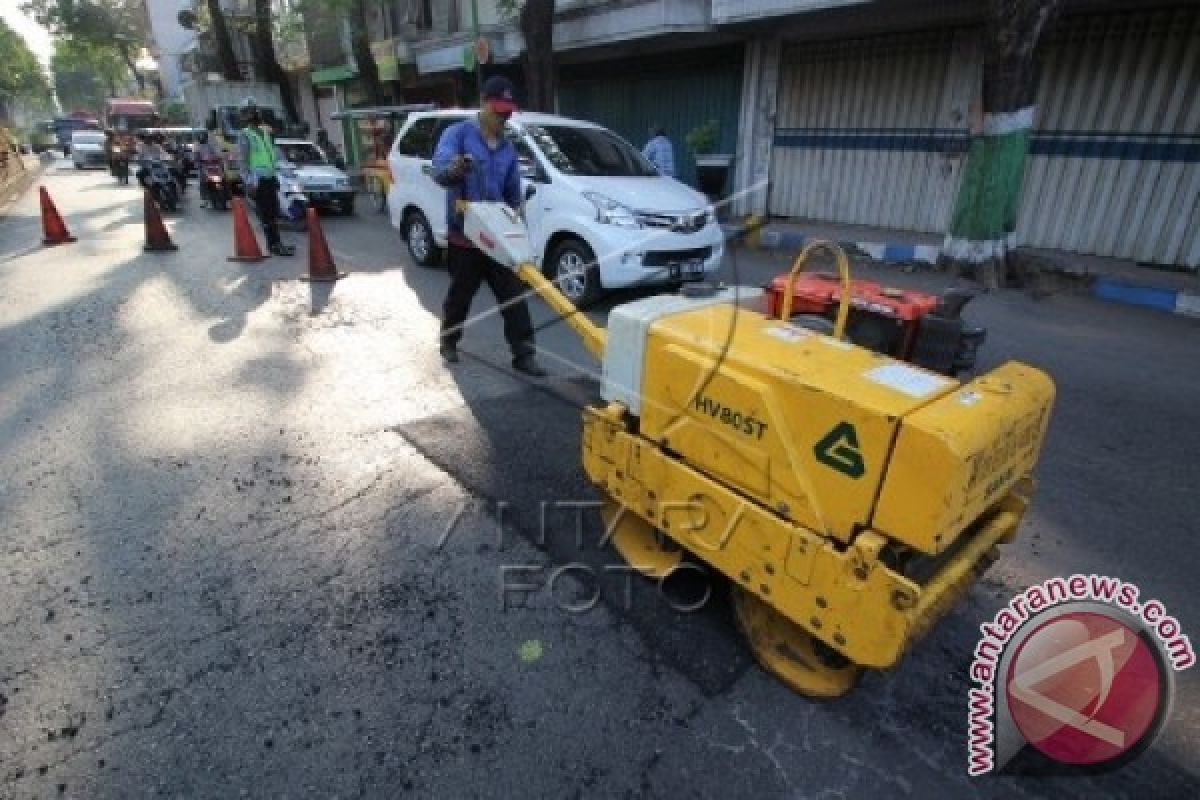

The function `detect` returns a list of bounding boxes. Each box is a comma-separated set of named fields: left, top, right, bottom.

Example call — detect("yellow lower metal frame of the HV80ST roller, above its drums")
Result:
left=583, top=404, right=1032, bottom=671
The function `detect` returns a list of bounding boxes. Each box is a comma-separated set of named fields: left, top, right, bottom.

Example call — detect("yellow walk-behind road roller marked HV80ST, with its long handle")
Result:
left=464, top=203, right=1055, bottom=697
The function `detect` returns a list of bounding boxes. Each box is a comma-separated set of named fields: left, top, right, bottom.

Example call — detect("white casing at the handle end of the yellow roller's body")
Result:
left=600, top=287, right=763, bottom=416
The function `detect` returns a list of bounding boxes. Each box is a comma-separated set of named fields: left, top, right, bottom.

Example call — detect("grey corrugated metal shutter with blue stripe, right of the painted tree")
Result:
left=1016, top=7, right=1200, bottom=267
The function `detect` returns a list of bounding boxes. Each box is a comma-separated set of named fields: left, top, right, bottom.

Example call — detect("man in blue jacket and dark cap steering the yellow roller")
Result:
left=433, top=76, right=546, bottom=378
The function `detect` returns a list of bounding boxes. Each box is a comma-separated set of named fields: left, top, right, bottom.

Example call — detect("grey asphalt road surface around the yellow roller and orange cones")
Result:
left=0, top=159, right=1200, bottom=800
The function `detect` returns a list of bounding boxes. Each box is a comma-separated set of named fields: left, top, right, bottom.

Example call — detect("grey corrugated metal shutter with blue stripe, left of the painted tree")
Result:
left=769, top=30, right=979, bottom=233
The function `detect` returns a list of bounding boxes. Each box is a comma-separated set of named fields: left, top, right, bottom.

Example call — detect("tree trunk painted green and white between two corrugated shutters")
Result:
left=942, top=0, right=1061, bottom=288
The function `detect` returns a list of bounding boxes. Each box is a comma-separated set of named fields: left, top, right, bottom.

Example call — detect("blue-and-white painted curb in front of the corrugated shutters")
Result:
left=725, top=219, right=1200, bottom=317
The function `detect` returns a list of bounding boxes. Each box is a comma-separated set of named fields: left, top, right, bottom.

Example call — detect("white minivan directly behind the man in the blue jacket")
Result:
left=388, top=109, right=725, bottom=302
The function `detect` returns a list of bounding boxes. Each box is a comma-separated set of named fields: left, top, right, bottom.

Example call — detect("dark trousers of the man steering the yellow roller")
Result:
left=442, top=243, right=534, bottom=357
